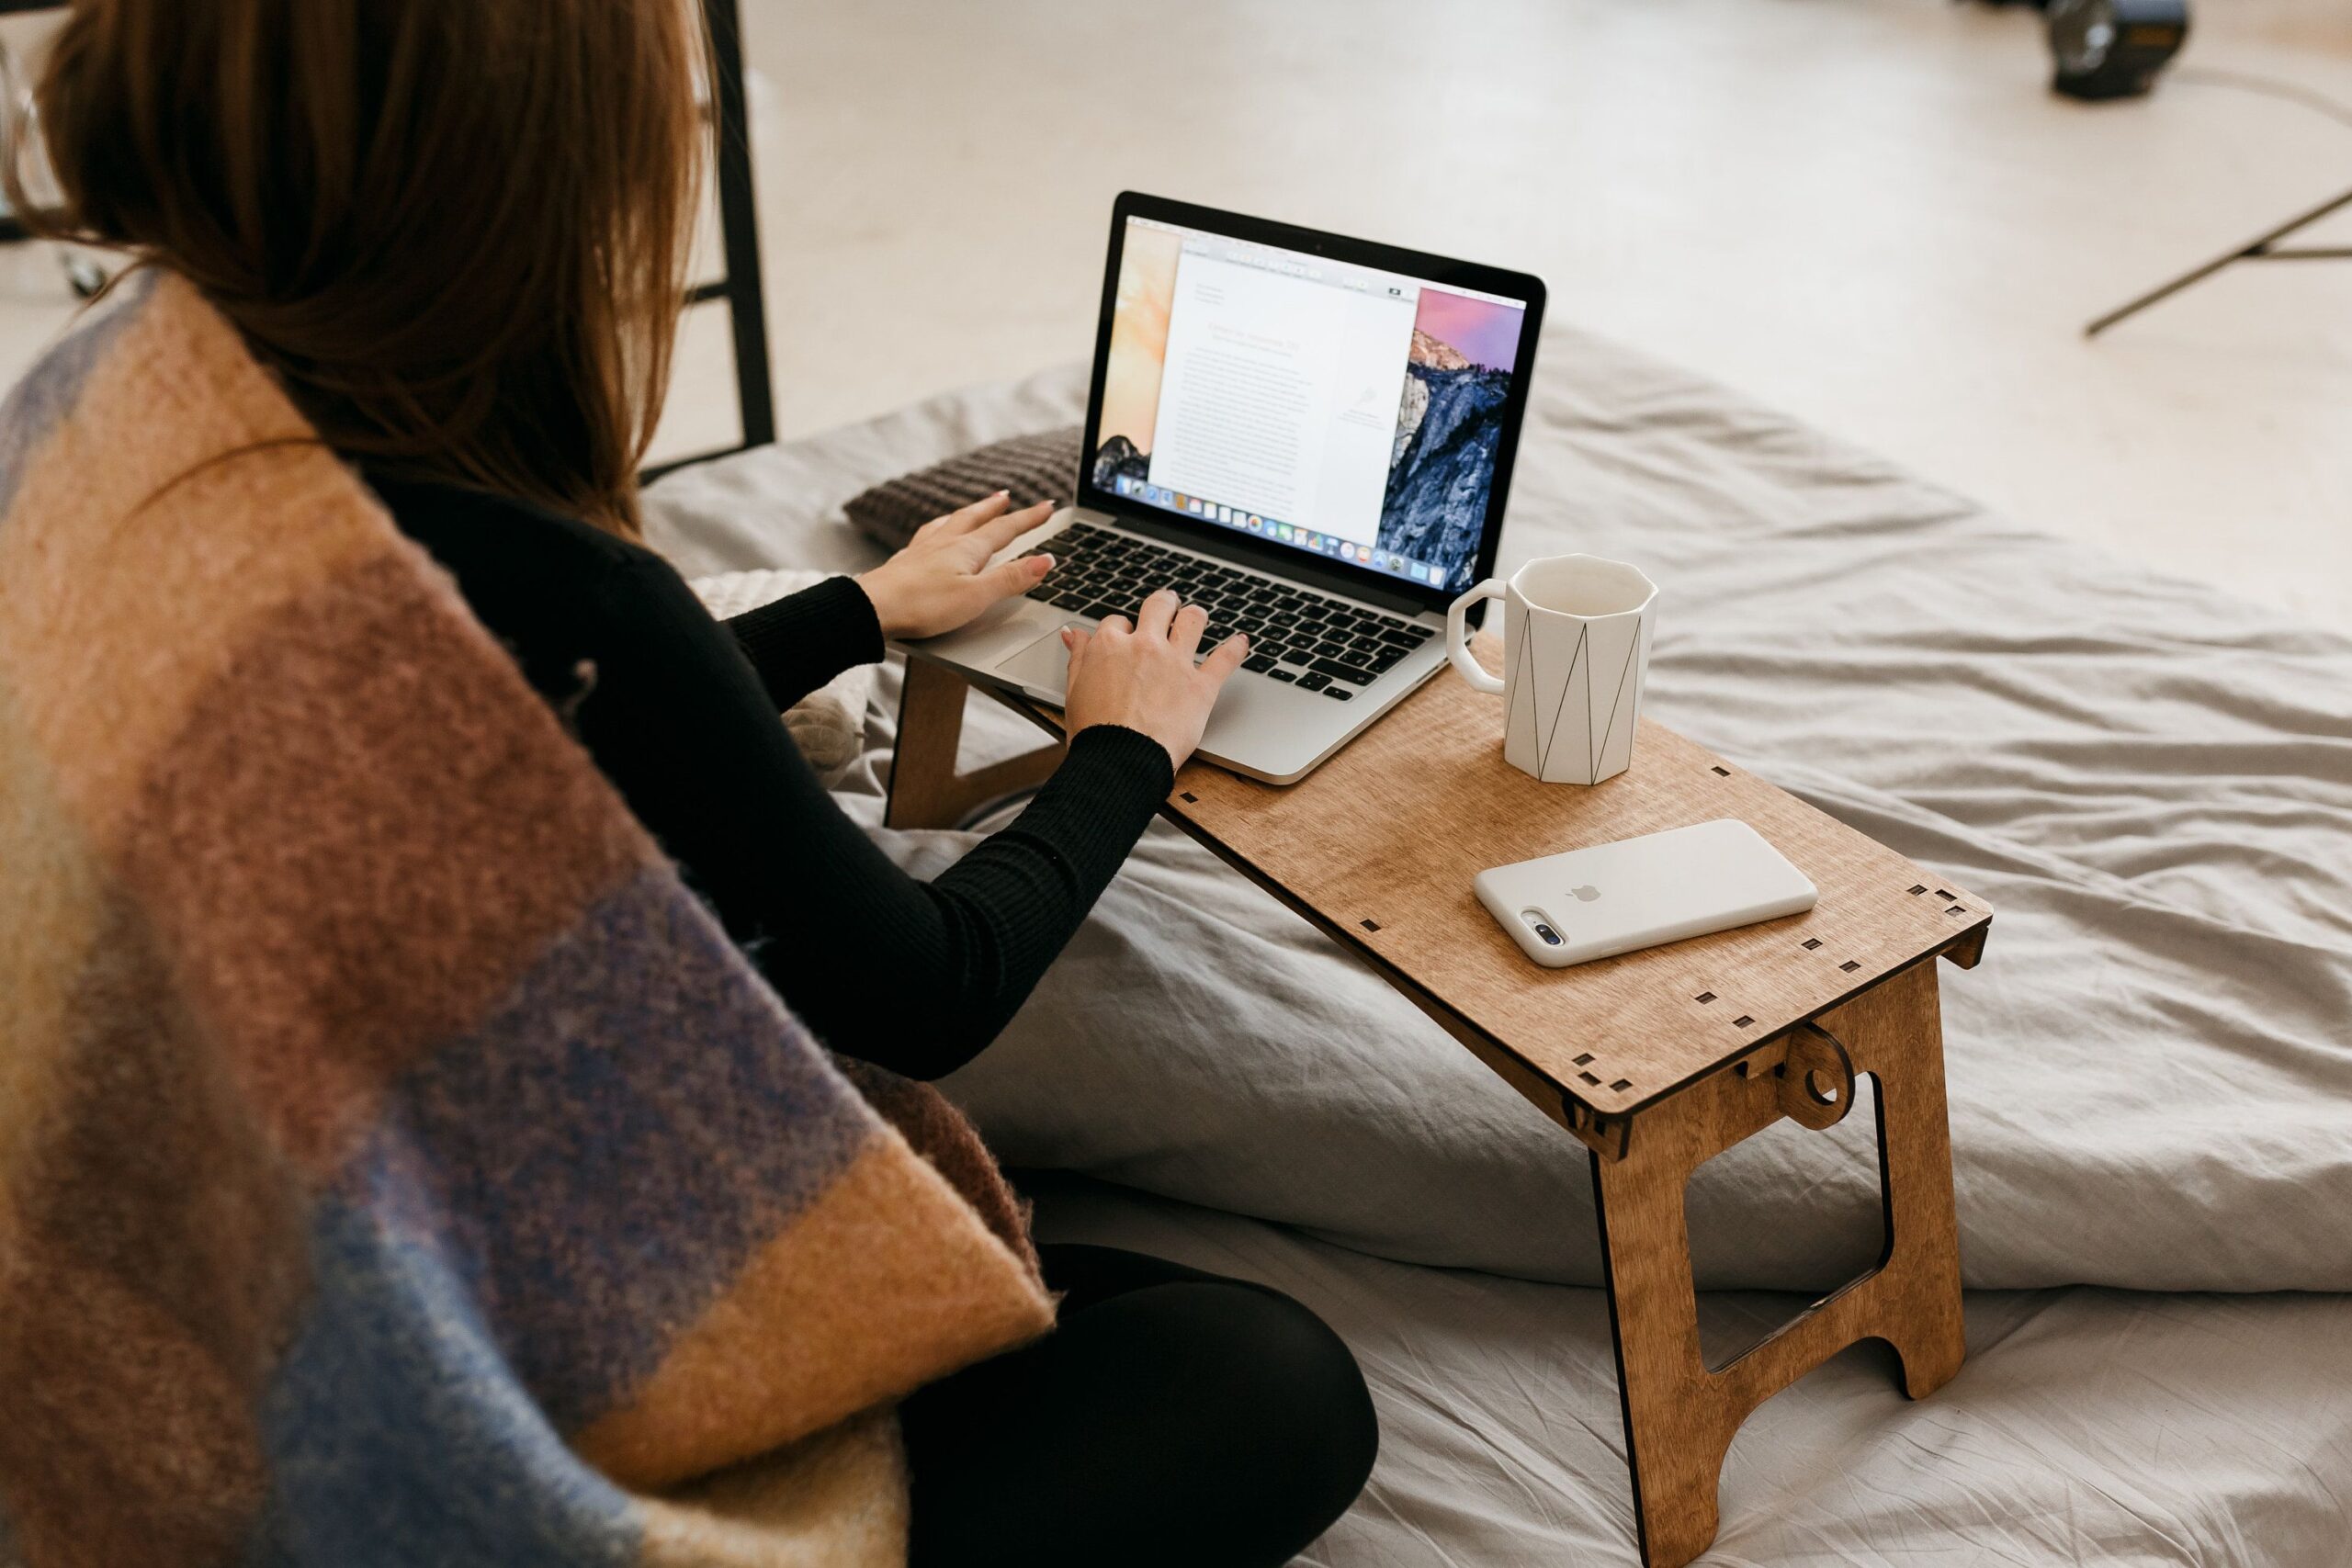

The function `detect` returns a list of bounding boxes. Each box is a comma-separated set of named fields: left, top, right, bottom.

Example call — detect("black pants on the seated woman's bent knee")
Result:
left=900, top=1246, right=1381, bottom=1568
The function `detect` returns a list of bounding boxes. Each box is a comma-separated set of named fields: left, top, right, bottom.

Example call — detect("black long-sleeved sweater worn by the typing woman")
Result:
left=371, top=478, right=1173, bottom=1079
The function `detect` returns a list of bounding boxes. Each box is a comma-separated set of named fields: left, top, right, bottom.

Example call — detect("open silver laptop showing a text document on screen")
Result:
left=906, top=193, right=1543, bottom=785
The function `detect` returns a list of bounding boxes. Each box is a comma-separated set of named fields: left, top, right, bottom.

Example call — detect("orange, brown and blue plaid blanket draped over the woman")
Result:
left=0, top=270, right=1051, bottom=1568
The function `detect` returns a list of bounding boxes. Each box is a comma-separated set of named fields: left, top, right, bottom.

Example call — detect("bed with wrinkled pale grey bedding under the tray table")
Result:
left=650, top=327, right=2352, bottom=1568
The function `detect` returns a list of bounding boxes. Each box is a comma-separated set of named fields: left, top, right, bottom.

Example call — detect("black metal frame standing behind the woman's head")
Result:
left=0, top=0, right=776, bottom=479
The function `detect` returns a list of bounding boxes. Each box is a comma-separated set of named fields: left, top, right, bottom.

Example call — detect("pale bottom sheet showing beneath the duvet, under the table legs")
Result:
left=1037, top=1178, right=2352, bottom=1568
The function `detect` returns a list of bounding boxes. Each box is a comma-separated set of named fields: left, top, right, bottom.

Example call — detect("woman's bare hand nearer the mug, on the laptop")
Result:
left=1061, top=588, right=1249, bottom=769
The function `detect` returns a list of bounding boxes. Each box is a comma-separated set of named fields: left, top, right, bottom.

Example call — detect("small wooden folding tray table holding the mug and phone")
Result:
left=889, top=649, right=1992, bottom=1568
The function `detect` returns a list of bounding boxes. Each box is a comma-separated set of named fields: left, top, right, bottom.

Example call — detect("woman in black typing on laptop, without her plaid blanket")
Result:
left=18, top=0, right=1376, bottom=1568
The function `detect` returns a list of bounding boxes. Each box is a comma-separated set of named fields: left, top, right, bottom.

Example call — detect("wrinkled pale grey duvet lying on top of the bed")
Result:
left=656, top=341, right=2352, bottom=1291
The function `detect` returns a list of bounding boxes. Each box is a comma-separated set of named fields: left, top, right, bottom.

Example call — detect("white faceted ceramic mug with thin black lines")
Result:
left=1446, top=555, right=1658, bottom=785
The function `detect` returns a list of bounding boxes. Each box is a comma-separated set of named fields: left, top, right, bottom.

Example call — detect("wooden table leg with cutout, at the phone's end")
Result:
left=1592, top=962, right=1966, bottom=1568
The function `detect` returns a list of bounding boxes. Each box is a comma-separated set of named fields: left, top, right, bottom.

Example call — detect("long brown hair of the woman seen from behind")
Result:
left=7, top=0, right=706, bottom=534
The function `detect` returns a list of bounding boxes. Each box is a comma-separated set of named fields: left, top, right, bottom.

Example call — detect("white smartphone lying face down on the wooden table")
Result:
left=1475, top=816, right=1820, bottom=968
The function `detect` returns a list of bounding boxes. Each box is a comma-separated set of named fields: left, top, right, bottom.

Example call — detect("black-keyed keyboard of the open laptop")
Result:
left=1028, top=522, right=1430, bottom=703
